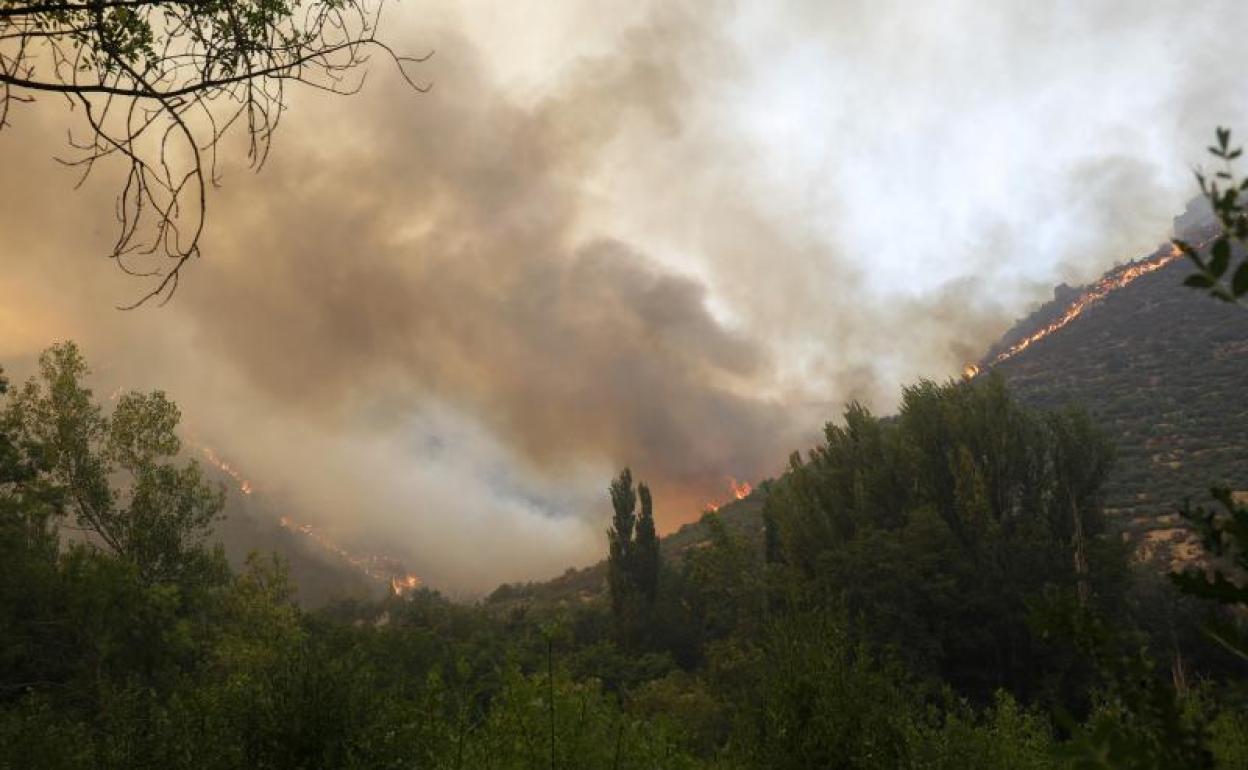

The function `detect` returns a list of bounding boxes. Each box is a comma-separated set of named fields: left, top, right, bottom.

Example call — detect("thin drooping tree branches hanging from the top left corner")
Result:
left=0, top=0, right=432, bottom=304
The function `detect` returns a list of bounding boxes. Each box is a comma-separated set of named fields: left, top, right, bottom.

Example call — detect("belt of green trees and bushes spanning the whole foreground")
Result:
left=0, top=344, right=1248, bottom=770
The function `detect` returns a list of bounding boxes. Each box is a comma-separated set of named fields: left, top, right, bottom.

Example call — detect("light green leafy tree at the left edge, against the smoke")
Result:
left=0, top=342, right=225, bottom=583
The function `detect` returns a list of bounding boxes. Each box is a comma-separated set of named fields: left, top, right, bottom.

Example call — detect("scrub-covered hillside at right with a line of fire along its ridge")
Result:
left=981, top=213, right=1248, bottom=528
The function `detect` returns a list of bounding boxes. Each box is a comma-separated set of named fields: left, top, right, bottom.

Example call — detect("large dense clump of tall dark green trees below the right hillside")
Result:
left=766, top=377, right=1123, bottom=700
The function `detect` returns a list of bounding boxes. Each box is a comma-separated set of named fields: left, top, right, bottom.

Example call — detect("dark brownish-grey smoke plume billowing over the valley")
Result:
left=177, top=22, right=794, bottom=499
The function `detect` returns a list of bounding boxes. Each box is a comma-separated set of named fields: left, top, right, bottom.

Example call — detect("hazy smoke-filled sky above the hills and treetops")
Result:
left=0, top=0, right=1248, bottom=592
